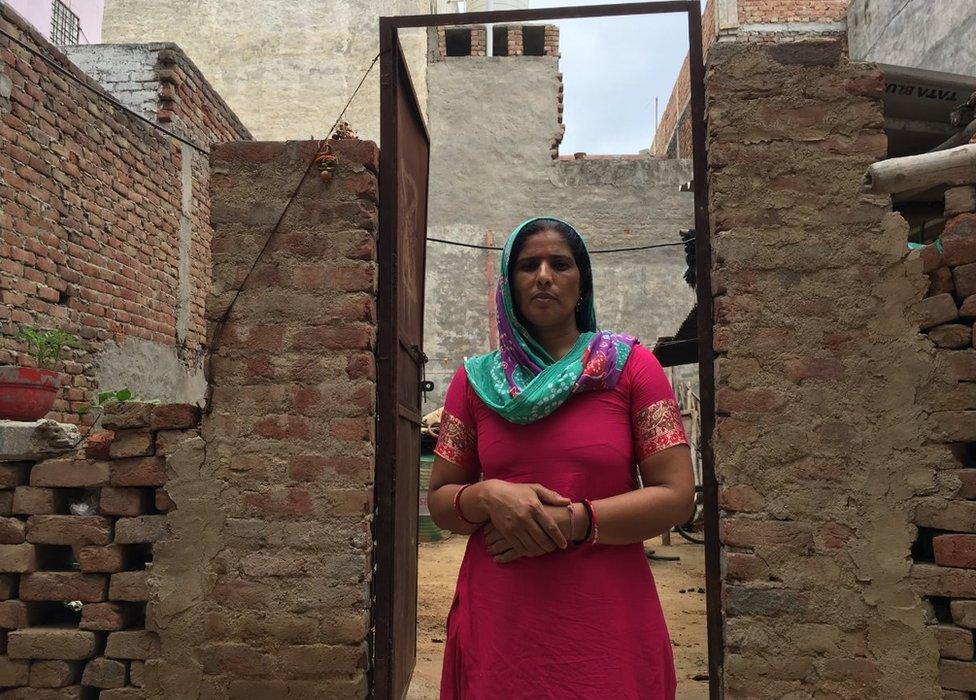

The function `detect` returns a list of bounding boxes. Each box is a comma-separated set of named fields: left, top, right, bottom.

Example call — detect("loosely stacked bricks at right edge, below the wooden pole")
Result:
left=912, top=185, right=976, bottom=700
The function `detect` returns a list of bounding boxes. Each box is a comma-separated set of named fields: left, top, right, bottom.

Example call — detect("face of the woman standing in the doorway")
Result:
left=512, top=230, right=580, bottom=329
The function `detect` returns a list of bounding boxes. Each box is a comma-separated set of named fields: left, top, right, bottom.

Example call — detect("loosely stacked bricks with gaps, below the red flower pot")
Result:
left=0, top=404, right=200, bottom=700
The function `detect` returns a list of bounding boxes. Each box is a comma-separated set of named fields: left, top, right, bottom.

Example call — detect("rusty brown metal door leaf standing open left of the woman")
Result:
left=371, top=20, right=430, bottom=698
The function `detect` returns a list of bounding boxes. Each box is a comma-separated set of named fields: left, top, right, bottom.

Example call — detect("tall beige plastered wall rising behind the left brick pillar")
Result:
left=103, top=0, right=430, bottom=140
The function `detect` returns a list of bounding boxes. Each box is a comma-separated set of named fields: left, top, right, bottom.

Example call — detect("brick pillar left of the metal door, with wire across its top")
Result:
left=194, top=140, right=379, bottom=698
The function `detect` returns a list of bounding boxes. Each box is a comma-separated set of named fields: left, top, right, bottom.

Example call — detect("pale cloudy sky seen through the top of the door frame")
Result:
left=529, top=0, right=688, bottom=154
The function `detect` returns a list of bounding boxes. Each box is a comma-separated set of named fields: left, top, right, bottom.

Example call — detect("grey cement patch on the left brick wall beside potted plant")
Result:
left=93, top=337, right=207, bottom=403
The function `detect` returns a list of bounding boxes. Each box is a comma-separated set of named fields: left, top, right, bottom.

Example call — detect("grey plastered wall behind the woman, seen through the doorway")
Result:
left=424, top=56, right=695, bottom=410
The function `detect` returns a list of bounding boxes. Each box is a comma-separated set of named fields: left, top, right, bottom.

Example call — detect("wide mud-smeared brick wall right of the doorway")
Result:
left=706, top=39, right=956, bottom=699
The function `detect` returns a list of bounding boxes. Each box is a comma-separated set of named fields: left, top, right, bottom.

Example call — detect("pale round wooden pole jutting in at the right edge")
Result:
left=864, top=144, right=976, bottom=194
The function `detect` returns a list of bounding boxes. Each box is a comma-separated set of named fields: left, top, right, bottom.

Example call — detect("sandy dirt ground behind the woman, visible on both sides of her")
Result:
left=407, top=535, right=708, bottom=700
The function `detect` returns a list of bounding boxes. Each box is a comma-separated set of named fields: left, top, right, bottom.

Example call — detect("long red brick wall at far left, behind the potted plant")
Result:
left=0, top=6, right=249, bottom=422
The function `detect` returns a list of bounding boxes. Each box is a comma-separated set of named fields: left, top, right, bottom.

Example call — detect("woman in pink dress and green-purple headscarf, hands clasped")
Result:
left=428, top=218, right=694, bottom=700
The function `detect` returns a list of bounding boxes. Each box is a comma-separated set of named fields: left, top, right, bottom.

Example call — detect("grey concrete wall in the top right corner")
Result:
left=847, top=0, right=976, bottom=76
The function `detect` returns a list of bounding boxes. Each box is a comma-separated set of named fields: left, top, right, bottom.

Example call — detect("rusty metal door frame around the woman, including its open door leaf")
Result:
left=371, top=1, right=722, bottom=698
